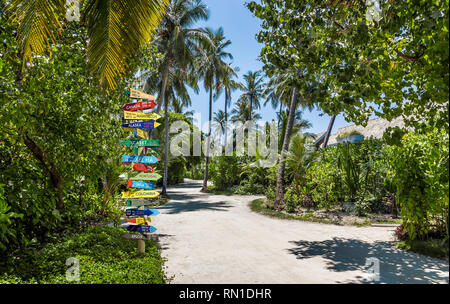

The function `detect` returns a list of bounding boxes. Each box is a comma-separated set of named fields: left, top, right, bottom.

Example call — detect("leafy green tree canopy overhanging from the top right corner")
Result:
left=247, top=0, right=449, bottom=129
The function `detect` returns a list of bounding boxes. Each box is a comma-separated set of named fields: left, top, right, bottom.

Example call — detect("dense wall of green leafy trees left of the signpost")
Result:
left=0, top=14, right=159, bottom=258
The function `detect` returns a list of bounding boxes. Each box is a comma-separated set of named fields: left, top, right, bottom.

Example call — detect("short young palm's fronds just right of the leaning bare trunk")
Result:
left=286, top=133, right=316, bottom=197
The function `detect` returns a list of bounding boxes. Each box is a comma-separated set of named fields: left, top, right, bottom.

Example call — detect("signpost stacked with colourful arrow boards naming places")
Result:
left=120, top=89, right=161, bottom=254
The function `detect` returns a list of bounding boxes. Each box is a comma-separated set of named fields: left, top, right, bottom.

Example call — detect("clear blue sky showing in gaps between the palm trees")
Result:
left=188, top=0, right=362, bottom=133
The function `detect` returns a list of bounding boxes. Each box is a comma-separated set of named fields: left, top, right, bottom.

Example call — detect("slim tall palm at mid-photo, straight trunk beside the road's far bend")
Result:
left=198, top=27, right=233, bottom=192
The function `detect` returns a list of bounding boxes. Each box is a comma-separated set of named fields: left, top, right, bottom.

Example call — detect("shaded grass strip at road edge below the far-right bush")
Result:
left=395, top=239, right=449, bottom=262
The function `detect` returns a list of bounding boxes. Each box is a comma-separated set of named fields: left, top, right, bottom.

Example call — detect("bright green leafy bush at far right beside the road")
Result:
left=388, top=129, right=449, bottom=239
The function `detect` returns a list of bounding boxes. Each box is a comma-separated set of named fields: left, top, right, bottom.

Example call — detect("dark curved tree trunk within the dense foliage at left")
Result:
left=23, top=134, right=64, bottom=211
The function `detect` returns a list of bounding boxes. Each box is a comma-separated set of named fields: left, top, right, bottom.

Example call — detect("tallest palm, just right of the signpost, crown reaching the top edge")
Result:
left=149, top=0, right=211, bottom=194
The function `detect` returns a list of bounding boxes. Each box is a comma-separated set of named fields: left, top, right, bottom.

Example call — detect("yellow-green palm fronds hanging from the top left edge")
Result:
left=6, top=0, right=169, bottom=88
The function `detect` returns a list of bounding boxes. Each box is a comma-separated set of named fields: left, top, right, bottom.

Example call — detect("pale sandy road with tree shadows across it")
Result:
left=153, top=180, right=449, bottom=284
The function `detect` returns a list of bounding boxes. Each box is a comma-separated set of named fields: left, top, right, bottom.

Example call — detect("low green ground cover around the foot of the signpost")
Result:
left=0, top=226, right=167, bottom=284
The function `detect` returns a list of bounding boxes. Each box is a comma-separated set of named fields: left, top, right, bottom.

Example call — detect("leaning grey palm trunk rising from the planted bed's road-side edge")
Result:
left=275, top=88, right=297, bottom=210
